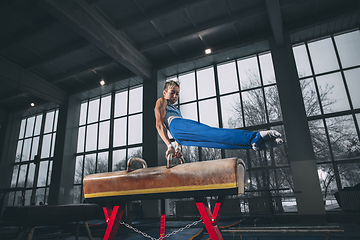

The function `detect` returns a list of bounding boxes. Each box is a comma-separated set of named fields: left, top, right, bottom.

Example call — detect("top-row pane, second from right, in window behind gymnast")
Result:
left=238, top=57, right=261, bottom=89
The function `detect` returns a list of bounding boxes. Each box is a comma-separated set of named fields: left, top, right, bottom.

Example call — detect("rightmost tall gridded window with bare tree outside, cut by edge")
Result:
left=293, top=31, right=360, bottom=210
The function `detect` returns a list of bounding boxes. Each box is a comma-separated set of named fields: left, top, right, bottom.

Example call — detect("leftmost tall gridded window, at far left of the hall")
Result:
left=8, top=109, right=58, bottom=206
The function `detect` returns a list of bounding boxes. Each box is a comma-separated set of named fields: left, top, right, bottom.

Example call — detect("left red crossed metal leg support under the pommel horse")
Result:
left=103, top=202, right=126, bottom=240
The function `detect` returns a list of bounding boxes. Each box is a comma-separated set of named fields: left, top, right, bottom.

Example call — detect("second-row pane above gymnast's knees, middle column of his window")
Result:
left=220, top=93, right=243, bottom=128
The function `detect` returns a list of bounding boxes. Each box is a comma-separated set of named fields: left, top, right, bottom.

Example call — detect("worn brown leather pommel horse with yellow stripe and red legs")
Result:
left=83, top=157, right=245, bottom=240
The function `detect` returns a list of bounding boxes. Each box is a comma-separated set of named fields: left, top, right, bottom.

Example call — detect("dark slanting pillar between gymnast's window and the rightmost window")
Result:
left=270, top=35, right=325, bottom=221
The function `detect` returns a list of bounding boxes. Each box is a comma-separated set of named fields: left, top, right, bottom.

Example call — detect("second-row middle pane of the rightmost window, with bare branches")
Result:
left=317, top=73, right=350, bottom=113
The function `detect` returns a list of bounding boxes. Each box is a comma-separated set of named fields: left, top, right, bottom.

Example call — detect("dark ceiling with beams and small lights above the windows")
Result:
left=0, top=0, right=360, bottom=112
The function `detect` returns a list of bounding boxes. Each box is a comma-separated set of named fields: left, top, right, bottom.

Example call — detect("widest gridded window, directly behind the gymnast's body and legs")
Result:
left=168, top=52, right=296, bottom=213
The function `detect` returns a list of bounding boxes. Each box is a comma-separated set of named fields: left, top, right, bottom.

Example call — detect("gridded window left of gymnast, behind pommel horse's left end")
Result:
left=74, top=86, right=143, bottom=203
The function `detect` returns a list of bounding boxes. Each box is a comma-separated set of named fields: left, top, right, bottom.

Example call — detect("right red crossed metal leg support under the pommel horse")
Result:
left=195, top=197, right=224, bottom=240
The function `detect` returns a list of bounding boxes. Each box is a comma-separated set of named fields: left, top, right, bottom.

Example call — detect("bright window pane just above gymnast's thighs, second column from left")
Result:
left=199, top=98, right=219, bottom=127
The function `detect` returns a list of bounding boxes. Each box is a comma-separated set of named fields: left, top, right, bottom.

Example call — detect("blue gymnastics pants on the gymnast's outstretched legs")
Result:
left=169, top=118, right=259, bottom=149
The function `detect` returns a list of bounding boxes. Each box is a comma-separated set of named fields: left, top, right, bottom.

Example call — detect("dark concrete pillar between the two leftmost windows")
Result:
left=48, top=98, right=81, bottom=205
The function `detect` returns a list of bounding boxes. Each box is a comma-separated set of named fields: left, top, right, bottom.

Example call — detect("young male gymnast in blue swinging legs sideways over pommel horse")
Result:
left=155, top=80, right=283, bottom=158
